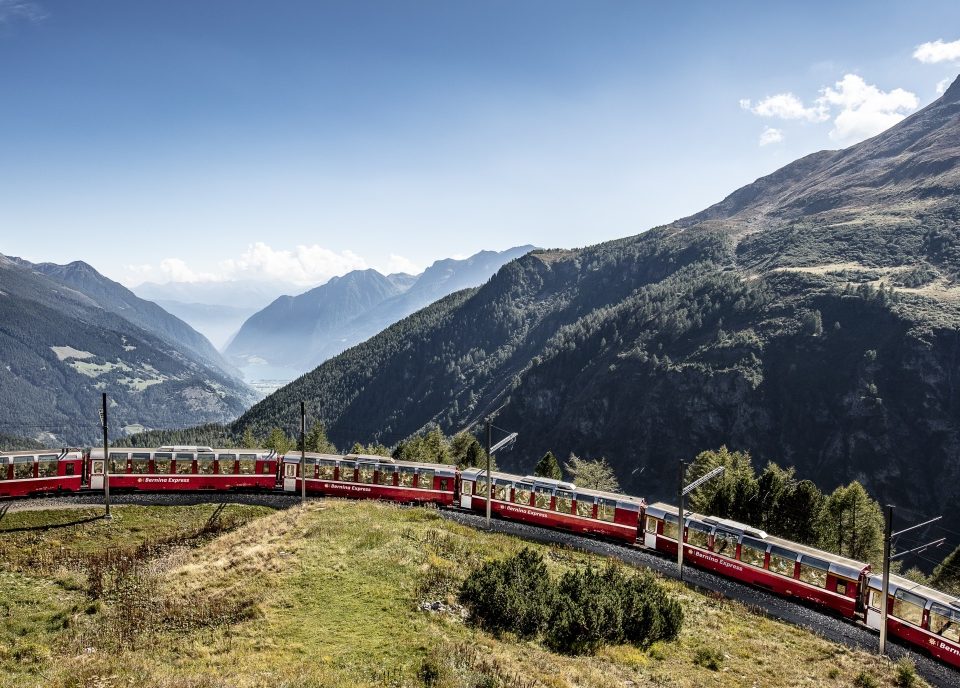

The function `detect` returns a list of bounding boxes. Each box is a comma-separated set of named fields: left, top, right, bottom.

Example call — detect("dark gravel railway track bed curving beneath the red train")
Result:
left=7, top=493, right=960, bottom=688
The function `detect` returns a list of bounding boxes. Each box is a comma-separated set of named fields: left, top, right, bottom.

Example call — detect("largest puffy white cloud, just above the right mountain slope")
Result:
left=817, top=74, right=920, bottom=143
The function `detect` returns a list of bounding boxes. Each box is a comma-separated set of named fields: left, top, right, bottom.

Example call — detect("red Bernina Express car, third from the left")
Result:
left=283, top=452, right=457, bottom=506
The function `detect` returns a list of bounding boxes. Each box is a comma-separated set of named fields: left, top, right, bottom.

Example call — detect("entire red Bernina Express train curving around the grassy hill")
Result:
left=0, top=446, right=960, bottom=667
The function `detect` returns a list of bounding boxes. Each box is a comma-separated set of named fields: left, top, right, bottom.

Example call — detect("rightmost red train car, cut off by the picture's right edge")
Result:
left=866, top=575, right=960, bottom=668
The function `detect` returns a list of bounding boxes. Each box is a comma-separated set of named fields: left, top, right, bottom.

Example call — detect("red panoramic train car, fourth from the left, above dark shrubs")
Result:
left=460, top=468, right=645, bottom=544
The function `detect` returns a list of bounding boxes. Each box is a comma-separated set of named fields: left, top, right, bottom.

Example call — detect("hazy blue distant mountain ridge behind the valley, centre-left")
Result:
left=225, top=246, right=533, bottom=374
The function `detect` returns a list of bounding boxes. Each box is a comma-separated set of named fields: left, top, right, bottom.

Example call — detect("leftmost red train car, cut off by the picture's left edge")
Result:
left=0, top=449, right=83, bottom=497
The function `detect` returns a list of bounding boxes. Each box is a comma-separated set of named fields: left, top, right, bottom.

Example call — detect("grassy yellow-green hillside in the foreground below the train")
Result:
left=0, top=501, right=921, bottom=688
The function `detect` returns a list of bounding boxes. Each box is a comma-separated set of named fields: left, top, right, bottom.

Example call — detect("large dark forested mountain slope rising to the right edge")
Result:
left=235, top=82, right=960, bottom=529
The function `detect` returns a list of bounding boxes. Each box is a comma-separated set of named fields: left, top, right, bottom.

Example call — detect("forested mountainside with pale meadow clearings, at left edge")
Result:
left=0, top=255, right=255, bottom=444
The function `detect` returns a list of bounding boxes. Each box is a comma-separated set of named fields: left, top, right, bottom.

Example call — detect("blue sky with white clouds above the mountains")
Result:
left=0, top=0, right=960, bottom=285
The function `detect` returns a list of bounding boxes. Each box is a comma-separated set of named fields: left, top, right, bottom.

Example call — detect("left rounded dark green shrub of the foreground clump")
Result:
left=460, top=547, right=554, bottom=638
